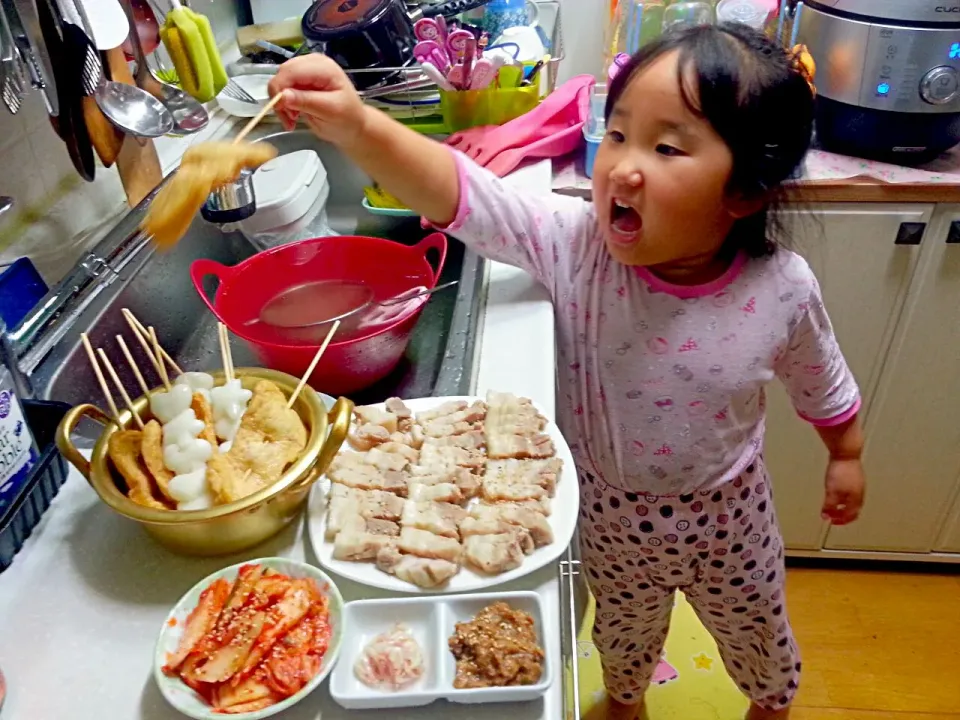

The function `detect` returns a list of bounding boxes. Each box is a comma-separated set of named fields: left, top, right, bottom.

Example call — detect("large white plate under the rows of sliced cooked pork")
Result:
left=307, top=397, right=580, bottom=594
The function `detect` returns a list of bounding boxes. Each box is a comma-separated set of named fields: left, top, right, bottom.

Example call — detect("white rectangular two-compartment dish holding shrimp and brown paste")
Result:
left=330, top=592, right=553, bottom=710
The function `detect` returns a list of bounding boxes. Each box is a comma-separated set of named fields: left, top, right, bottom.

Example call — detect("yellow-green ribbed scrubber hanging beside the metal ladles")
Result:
left=160, top=0, right=228, bottom=102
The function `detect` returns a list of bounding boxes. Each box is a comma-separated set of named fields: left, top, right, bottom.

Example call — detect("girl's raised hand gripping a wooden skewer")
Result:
left=268, top=53, right=367, bottom=149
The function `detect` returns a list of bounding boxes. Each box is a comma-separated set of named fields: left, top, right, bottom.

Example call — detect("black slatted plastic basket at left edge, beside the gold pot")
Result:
left=0, top=400, right=70, bottom=572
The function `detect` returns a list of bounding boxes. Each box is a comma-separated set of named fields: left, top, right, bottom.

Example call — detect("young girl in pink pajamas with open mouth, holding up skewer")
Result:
left=271, top=26, right=864, bottom=720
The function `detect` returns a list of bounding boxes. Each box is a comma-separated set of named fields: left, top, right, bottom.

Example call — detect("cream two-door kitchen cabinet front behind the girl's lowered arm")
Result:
left=766, top=203, right=960, bottom=562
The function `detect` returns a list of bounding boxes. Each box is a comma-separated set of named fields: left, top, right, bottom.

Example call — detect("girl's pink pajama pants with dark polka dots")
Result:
left=580, top=458, right=800, bottom=710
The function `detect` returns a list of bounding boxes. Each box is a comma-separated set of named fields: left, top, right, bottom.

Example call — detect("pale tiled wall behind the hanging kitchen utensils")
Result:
left=0, top=0, right=244, bottom=284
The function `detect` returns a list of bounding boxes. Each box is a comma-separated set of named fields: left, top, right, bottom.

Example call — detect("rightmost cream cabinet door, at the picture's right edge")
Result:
left=824, top=205, right=960, bottom=553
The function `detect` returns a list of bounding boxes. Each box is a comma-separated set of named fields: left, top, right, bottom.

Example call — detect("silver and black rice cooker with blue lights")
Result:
left=793, top=0, right=960, bottom=163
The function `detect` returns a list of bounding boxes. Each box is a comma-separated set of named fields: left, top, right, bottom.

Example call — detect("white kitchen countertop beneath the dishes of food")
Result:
left=0, top=162, right=563, bottom=720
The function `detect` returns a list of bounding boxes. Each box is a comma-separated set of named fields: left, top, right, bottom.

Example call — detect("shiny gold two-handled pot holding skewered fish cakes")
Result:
left=57, top=368, right=353, bottom=555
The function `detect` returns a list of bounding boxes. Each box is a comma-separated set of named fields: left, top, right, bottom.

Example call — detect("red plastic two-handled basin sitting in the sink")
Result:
left=190, top=233, right=447, bottom=395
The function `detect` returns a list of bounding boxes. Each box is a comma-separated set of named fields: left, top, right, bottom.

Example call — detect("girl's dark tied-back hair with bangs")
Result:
left=606, top=23, right=814, bottom=257
